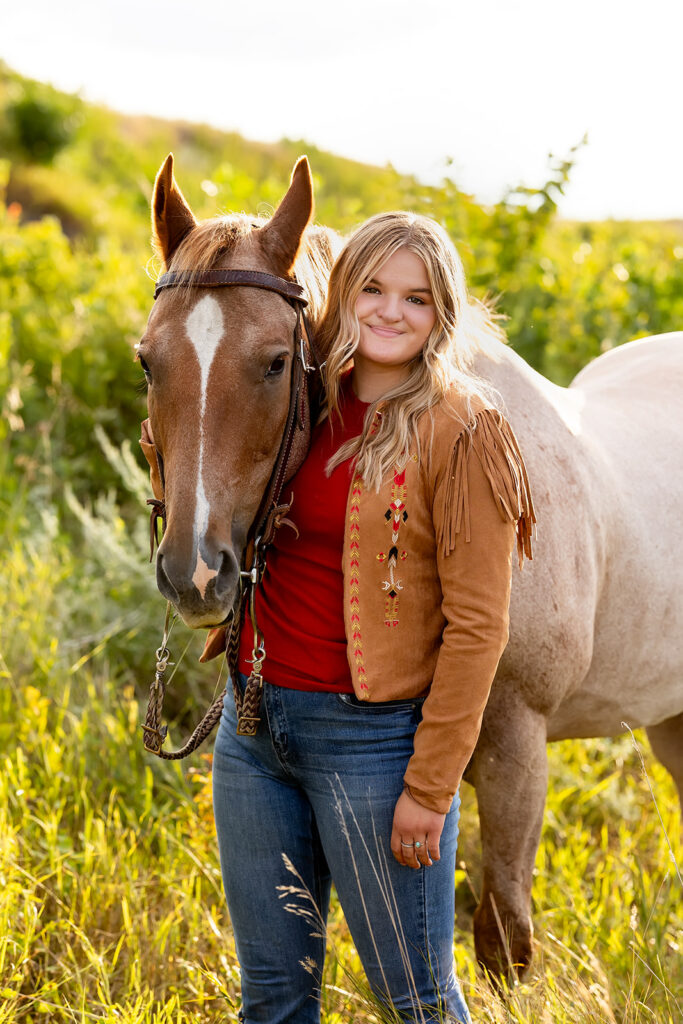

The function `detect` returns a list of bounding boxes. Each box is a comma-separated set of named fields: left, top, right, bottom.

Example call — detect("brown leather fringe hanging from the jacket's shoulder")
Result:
left=437, top=409, right=536, bottom=568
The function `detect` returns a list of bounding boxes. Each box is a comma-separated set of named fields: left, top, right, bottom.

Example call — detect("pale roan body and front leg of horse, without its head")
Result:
left=468, top=334, right=683, bottom=965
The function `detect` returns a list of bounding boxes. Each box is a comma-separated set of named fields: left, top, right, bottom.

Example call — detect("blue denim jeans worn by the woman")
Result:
left=213, top=677, right=470, bottom=1024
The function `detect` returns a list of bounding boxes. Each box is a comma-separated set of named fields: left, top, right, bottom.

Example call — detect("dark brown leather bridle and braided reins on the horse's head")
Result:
left=142, top=270, right=324, bottom=761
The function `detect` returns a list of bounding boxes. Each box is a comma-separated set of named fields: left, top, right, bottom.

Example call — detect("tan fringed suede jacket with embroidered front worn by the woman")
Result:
left=143, top=391, right=536, bottom=813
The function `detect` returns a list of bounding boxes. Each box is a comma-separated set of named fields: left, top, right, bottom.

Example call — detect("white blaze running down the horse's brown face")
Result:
left=185, top=295, right=223, bottom=598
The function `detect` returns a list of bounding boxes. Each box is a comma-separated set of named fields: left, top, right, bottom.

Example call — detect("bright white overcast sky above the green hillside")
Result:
left=0, top=0, right=683, bottom=218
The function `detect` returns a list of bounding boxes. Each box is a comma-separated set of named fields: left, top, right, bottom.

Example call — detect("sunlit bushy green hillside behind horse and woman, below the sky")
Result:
left=0, top=66, right=683, bottom=503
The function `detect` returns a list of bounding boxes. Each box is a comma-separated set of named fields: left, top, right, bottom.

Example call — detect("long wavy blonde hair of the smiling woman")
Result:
left=317, top=211, right=505, bottom=490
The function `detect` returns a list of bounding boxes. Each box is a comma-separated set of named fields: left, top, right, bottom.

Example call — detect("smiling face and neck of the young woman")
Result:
left=353, top=247, right=436, bottom=395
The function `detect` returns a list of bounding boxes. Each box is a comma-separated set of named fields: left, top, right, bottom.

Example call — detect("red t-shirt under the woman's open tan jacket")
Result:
left=240, top=379, right=368, bottom=693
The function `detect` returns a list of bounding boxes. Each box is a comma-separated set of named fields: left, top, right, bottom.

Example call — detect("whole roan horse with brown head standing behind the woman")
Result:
left=138, top=151, right=683, bottom=976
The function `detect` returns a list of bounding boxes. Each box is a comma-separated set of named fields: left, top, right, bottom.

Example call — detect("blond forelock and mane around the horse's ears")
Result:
left=163, top=213, right=341, bottom=325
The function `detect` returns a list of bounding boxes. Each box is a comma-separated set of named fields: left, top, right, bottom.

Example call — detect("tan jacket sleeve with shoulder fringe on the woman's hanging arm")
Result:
left=404, top=410, right=536, bottom=813
